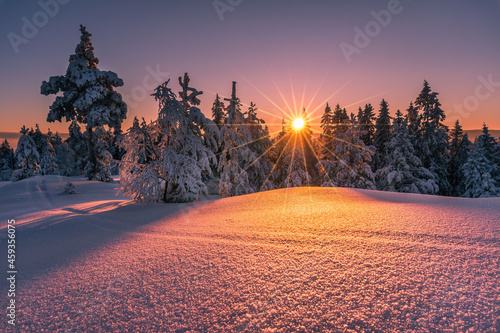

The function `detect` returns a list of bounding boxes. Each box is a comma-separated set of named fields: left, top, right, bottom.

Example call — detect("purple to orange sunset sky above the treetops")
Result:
left=0, top=0, right=500, bottom=138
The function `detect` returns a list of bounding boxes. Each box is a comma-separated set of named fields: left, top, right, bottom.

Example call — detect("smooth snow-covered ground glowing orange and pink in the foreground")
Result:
left=0, top=176, right=500, bottom=332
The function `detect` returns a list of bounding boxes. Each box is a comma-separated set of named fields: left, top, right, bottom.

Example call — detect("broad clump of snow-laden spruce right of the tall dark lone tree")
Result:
left=120, top=75, right=217, bottom=202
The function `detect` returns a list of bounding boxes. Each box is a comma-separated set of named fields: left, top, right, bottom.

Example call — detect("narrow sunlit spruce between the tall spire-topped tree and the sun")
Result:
left=244, top=102, right=274, bottom=191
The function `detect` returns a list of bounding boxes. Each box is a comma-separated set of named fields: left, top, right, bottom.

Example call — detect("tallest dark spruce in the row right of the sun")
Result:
left=415, top=81, right=451, bottom=195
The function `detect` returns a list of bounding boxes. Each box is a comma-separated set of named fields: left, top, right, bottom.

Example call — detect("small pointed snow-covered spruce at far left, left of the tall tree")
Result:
left=12, top=126, right=40, bottom=181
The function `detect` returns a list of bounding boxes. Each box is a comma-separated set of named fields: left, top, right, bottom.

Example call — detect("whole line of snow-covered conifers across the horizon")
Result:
left=0, top=26, right=500, bottom=202
